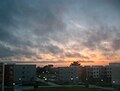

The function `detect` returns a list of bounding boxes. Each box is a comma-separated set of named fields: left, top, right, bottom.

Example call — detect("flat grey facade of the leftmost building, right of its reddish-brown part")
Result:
left=14, top=64, right=36, bottom=84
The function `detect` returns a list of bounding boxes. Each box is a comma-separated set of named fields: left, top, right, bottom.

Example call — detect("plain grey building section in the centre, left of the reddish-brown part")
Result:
left=58, top=66, right=81, bottom=83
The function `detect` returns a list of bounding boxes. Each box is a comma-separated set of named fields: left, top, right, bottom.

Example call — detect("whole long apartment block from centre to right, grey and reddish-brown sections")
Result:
left=58, top=66, right=112, bottom=85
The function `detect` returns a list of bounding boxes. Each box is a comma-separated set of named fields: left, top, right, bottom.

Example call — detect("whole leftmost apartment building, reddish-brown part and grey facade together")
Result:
left=0, top=63, right=36, bottom=86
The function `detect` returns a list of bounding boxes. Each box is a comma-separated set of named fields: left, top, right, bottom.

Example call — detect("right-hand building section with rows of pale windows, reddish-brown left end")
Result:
left=81, top=66, right=111, bottom=85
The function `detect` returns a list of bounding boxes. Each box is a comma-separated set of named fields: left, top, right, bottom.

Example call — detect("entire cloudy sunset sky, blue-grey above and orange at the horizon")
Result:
left=0, top=0, right=120, bottom=66
